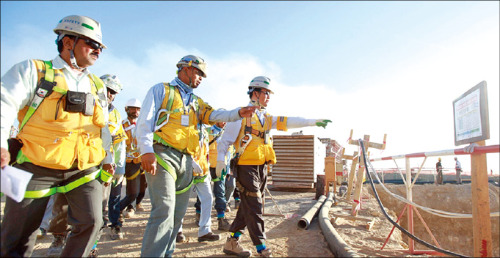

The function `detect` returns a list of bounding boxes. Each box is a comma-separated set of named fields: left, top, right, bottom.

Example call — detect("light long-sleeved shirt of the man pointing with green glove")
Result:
left=217, top=102, right=317, bottom=162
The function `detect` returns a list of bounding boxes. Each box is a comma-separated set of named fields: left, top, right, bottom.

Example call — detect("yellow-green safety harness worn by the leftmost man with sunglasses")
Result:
left=16, top=61, right=113, bottom=199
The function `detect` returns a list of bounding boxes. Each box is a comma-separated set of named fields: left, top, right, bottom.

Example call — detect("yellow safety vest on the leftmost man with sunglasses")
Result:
left=17, top=60, right=106, bottom=170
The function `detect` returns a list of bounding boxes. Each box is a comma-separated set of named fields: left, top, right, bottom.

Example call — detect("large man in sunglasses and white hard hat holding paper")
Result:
left=1, top=15, right=114, bottom=257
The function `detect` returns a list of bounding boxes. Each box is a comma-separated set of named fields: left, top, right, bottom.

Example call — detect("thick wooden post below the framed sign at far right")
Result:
left=471, top=140, right=493, bottom=257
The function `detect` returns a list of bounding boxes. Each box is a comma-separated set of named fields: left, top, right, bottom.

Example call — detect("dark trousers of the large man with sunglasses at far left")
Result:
left=0, top=162, right=102, bottom=257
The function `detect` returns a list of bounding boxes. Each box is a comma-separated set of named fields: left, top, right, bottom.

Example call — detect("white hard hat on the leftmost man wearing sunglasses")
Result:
left=54, top=15, right=106, bottom=48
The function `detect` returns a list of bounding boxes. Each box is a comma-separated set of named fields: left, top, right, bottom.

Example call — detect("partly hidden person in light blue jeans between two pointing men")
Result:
left=176, top=122, right=221, bottom=243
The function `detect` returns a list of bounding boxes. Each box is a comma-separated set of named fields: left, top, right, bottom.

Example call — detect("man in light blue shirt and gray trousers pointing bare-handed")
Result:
left=136, top=55, right=255, bottom=257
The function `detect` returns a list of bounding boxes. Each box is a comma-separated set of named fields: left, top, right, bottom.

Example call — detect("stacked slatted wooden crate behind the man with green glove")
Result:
left=271, top=135, right=326, bottom=188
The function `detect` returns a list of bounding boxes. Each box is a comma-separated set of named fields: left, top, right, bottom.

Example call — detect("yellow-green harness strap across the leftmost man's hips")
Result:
left=24, top=169, right=113, bottom=199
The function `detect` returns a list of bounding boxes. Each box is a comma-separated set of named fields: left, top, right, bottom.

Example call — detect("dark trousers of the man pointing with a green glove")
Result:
left=229, top=165, right=267, bottom=245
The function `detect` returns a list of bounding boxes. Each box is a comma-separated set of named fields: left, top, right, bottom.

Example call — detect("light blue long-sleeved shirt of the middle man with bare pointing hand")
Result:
left=136, top=79, right=241, bottom=155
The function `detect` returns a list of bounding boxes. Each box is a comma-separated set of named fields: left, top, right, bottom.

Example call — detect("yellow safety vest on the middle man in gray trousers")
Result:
left=155, top=83, right=213, bottom=155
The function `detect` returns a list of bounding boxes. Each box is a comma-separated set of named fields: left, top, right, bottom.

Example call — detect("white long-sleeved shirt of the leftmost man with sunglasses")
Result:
left=0, top=56, right=113, bottom=164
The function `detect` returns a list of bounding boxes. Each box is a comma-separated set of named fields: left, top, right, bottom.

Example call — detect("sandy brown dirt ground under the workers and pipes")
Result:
left=1, top=180, right=500, bottom=257
